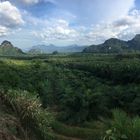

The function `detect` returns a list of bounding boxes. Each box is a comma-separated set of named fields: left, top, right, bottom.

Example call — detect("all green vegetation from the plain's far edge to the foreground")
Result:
left=0, top=53, right=140, bottom=140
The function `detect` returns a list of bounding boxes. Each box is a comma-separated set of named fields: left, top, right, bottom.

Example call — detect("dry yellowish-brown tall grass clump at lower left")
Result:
left=1, top=90, right=53, bottom=140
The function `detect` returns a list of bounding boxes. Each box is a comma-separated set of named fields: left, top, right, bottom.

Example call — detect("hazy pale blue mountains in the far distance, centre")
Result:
left=28, top=44, right=85, bottom=54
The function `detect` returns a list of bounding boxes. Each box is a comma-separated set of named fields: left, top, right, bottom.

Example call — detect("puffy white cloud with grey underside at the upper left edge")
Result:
left=0, top=1, right=24, bottom=36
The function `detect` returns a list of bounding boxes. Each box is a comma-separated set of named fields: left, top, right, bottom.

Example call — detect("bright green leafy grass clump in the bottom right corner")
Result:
left=104, top=110, right=140, bottom=140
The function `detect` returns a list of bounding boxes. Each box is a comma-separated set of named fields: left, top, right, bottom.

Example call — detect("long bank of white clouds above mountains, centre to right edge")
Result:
left=33, top=10, right=140, bottom=44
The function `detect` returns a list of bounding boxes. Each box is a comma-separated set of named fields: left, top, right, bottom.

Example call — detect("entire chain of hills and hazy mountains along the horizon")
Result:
left=0, top=34, right=140, bottom=56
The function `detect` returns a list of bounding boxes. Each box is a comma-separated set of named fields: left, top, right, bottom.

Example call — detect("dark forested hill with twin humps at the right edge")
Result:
left=83, top=35, right=140, bottom=53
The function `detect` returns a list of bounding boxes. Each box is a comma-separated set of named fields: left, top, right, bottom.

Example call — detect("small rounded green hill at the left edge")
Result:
left=0, top=40, right=24, bottom=56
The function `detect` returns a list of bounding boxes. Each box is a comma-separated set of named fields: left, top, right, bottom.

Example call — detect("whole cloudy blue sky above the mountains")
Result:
left=0, top=0, right=140, bottom=50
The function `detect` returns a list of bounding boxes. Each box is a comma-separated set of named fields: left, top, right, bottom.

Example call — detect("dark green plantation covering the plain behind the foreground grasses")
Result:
left=0, top=54, right=140, bottom=123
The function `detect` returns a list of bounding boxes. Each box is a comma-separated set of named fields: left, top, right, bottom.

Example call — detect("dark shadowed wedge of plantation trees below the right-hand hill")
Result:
left=51, top=57, right=140, bottom=84
